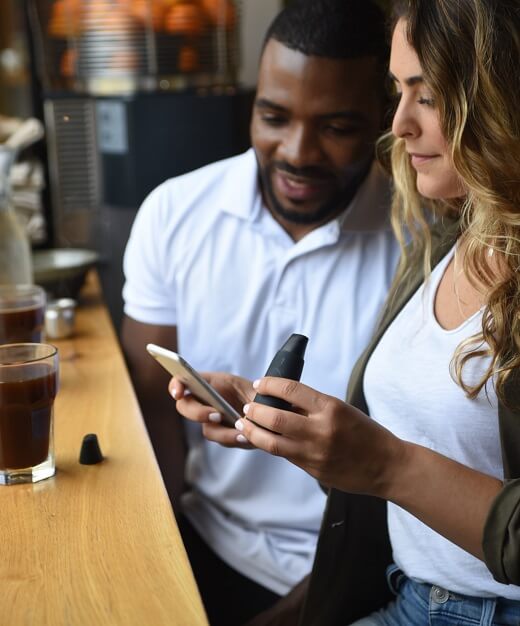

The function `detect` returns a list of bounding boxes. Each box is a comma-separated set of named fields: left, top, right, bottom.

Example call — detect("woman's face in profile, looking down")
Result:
left=390, top=20, right=464, bottom=199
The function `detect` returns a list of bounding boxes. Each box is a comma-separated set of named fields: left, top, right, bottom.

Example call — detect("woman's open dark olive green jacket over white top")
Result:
left=300, top=222, right=520, bottom=626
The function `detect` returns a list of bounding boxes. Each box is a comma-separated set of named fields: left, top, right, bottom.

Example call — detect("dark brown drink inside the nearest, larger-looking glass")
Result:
left=0, top=363, right=56, bottom=470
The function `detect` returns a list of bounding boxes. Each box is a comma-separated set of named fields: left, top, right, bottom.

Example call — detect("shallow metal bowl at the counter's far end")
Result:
left=33, top=248, right=99, bottom=298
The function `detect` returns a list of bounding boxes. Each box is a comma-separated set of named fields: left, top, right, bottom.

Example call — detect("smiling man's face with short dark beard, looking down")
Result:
left=251, top=39, right=383, bottom=225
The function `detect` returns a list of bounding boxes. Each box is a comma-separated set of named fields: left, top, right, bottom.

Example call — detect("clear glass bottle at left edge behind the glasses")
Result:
left=0, top=145, right=33, bottom=285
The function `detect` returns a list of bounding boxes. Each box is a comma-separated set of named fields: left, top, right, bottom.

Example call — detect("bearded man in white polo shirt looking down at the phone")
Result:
left=122, top=0, right=397, bottom=626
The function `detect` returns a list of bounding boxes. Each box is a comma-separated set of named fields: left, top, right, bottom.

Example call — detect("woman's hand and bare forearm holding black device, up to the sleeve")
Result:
left=236, top=377, right=502, bottom=559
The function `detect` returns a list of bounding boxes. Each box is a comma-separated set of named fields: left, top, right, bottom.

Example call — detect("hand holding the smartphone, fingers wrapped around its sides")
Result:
left=168, top=372, right=255, bottom=448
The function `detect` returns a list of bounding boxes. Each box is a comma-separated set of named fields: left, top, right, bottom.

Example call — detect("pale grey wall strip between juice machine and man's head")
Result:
left=240, top=0, right=282, bottom=86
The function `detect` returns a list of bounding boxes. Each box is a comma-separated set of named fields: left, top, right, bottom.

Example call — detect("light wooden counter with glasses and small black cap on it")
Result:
left=0, top=274, right=207, bottom=626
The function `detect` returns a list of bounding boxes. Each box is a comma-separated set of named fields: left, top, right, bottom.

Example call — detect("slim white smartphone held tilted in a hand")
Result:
left=146, top=343, right=242, bottom=427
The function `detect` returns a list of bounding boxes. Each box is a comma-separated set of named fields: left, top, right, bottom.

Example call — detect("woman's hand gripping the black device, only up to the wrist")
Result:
left=236, top=377, right=407, bottom=497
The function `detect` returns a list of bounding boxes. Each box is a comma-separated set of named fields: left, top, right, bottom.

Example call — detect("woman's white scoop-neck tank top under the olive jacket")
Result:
left=364, top=249, right=520, bottom=600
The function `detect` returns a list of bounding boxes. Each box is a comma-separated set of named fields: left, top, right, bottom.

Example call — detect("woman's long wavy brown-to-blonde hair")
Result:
left=380, top=0, right=520, bottom=408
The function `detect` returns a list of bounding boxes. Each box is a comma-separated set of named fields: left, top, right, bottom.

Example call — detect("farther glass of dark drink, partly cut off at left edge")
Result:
left=0, top=285, right=45, bottom=345
